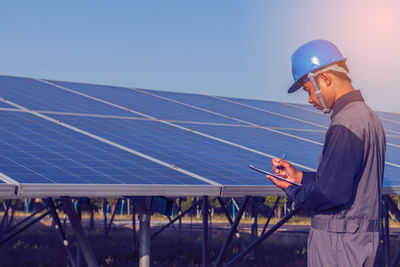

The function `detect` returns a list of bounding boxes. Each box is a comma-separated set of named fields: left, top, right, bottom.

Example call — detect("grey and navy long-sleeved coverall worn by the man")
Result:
left=286, top=90, right=386, bottom=267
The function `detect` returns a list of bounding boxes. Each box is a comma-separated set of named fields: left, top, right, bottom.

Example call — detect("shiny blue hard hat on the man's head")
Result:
left=288, top=40, right=346, bottom=93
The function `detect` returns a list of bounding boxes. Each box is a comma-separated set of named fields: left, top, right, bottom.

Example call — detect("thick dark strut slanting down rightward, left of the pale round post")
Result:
left=61, top=197, right=98, bottom=266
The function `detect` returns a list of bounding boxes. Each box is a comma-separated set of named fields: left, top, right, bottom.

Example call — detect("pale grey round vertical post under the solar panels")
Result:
left=139, top=211, right=150, bottom=267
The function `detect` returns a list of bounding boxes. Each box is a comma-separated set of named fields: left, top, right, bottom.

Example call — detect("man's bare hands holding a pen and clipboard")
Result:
left=267, top=158, right=303, bottom=190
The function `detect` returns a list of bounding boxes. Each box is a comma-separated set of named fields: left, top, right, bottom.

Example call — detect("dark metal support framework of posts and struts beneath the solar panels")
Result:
left=0, top=195, right=400, bottom=267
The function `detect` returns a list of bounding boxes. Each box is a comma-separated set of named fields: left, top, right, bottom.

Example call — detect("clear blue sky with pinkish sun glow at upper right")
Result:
left=0, top=0, right=400, bottom=113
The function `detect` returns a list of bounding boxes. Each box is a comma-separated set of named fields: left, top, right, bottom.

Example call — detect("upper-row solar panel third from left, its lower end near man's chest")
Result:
left=142, top=90, right=321, bottom=129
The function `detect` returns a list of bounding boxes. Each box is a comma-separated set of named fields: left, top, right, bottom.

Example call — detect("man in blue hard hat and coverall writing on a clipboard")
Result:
left=267, top=40, right=386, bottom=267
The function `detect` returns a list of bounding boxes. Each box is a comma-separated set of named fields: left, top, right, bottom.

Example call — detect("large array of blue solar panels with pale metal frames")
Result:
left=0, top=76, right=400, bottom=197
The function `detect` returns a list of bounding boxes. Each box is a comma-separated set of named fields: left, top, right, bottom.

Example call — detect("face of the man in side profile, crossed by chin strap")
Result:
left=303, top=75, right=334, bottom=110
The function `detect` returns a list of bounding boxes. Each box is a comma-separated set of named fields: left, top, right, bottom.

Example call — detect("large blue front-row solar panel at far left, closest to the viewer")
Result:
left=0, top=111, right=206, bottom=185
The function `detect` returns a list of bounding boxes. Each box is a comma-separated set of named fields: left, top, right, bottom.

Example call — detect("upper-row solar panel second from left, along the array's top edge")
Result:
left=47, top=81, right=238, bottom=124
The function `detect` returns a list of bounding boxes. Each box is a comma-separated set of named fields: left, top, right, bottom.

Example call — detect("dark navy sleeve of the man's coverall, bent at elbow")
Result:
left=286, top=125, right=364, bottom=211
